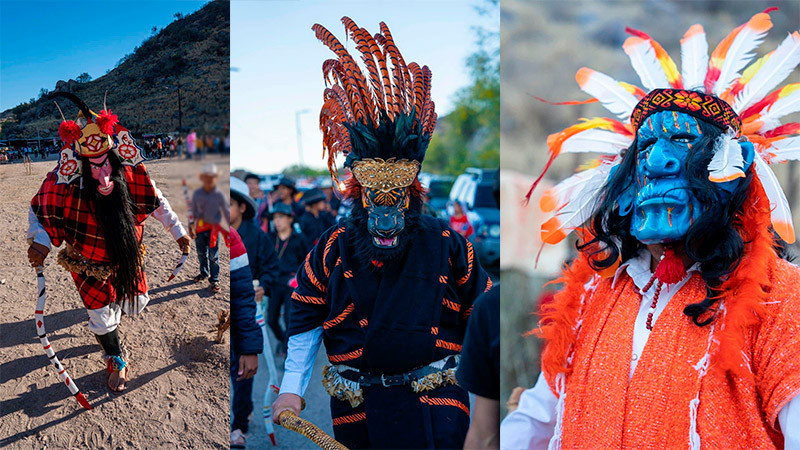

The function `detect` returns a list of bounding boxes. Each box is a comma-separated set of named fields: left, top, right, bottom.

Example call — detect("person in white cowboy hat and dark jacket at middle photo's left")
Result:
left=230, top=178, right=278, bottom=302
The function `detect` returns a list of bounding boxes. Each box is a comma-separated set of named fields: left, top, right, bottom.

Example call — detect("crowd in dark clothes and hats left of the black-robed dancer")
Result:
left=230, top=174, right=340, bottom=447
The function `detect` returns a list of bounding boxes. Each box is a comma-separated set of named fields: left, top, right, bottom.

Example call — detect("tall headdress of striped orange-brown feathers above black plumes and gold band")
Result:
left=311, top=17, right=436, bottom=191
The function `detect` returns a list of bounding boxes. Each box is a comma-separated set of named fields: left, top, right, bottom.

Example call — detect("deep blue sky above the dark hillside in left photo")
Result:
left=0, top=0, right=206, bottom=111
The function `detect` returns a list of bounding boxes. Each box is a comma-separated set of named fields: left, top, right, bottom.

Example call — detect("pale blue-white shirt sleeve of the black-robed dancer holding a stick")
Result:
left=281, top=327, right=322, bottom=397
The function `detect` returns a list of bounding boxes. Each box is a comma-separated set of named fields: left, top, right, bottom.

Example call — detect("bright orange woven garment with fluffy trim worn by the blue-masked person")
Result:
left=535, top=179, right=800, bottom=448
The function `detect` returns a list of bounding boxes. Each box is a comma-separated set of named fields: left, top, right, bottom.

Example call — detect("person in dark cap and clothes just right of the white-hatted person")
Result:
left=267, top=203, right=309, bottom=354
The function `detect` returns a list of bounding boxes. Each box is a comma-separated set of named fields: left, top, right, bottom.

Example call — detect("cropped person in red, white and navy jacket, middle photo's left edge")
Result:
left=230, top=227, right=264, bottom=448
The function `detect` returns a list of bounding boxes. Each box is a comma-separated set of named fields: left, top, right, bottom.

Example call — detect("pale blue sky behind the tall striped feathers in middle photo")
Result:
left=231, top=0, right=500, bottom=173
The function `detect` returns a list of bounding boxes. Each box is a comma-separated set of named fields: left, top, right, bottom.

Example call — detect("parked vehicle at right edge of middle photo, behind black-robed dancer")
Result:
left=447, top=167, right=500, bottom=268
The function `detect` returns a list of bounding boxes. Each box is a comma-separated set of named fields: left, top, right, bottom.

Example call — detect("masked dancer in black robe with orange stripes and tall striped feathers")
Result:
left=272, top=18, right=491, bottom=449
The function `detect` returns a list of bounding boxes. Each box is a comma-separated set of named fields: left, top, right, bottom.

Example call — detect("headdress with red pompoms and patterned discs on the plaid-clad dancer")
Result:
left=50, top=92, right=144, bottom=184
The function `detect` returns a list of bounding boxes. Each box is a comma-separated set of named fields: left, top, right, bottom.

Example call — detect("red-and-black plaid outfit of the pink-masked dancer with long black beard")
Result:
left=31, top=164, right=159, bottom=309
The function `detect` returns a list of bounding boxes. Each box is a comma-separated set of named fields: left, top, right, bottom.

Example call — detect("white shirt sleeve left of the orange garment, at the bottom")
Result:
left=500, top=374, right=558, bottom=450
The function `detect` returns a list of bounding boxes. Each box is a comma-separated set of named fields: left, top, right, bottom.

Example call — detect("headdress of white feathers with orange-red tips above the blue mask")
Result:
left=527, top=8, right=800, bottom=244
